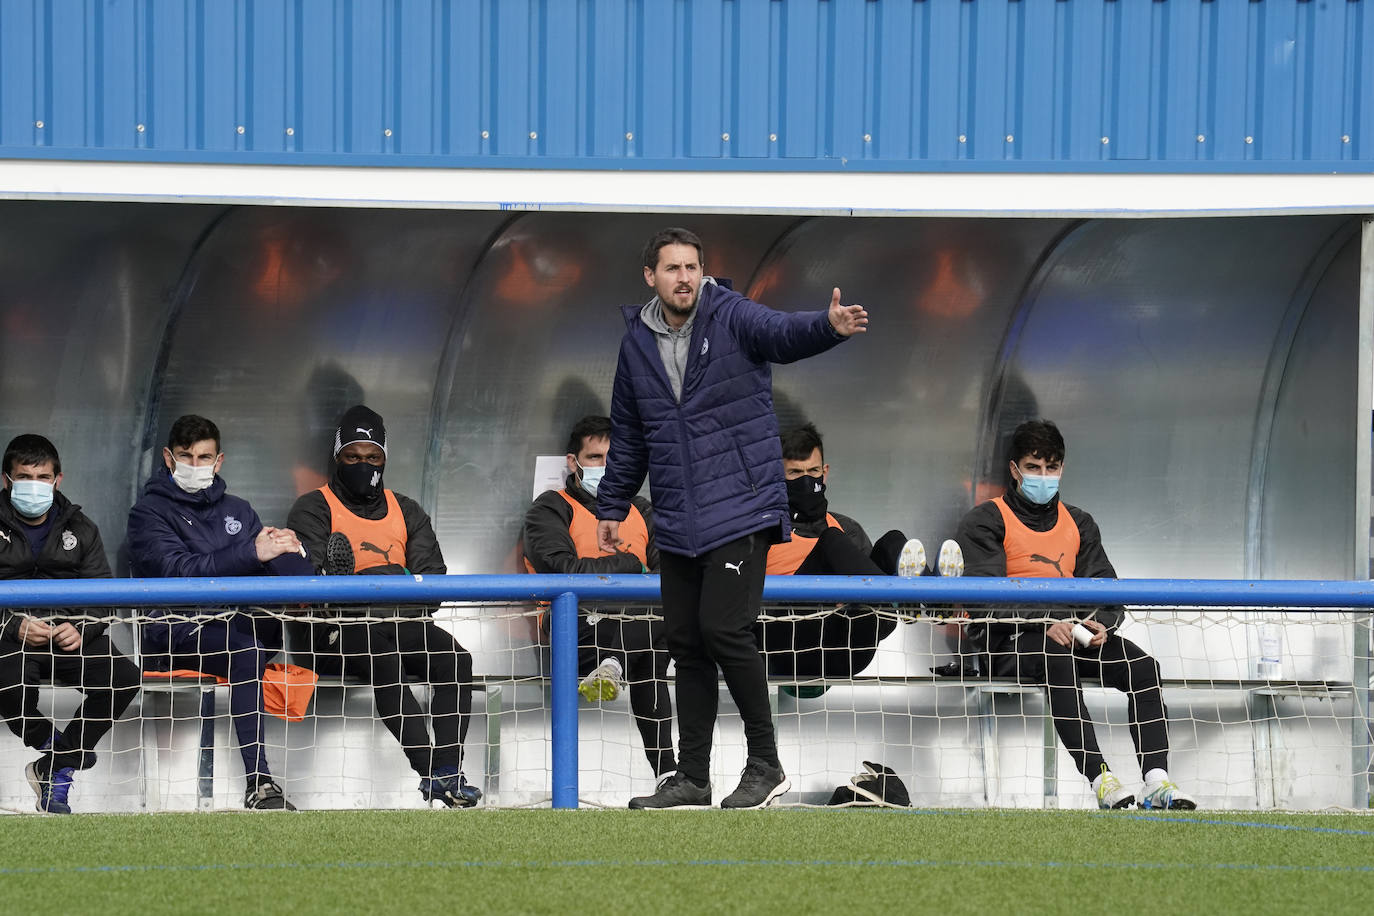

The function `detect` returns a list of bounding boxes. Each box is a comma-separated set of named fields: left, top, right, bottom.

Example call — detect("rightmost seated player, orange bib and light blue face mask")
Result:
left=958, top=420, right=1197, bottom=809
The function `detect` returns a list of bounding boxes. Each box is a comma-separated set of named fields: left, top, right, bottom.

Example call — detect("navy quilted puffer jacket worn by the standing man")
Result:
left=596, top=280, right=842, bottom=556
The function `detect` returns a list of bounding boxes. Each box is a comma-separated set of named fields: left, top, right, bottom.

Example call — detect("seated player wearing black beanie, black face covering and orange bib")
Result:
left=287, top=404, right=482, bottom=808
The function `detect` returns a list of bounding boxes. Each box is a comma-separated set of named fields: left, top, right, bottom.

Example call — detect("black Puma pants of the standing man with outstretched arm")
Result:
left=660, top=531, right=780, bottom=783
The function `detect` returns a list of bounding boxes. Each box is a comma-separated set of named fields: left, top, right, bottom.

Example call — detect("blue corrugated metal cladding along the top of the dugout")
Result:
left=0, top=0, right=1374, bottom=172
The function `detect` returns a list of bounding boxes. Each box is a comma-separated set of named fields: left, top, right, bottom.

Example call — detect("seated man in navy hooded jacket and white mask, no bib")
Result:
left=129, top=413, right=315, bottom=810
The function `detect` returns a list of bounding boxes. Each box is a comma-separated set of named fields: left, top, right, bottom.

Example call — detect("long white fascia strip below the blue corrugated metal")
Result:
left=0, top=159, right=1374, bottom=217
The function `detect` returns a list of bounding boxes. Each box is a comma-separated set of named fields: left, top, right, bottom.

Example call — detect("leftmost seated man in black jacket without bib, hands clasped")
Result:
left=0, top=434, right=143, bottom=814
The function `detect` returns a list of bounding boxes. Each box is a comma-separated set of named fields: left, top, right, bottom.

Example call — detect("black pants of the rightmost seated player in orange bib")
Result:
left=1015, top=626, right=1169, bottom=780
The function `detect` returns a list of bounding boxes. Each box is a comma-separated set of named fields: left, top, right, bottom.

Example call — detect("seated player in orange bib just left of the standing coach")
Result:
left=521, top=416, right=677, bottom=777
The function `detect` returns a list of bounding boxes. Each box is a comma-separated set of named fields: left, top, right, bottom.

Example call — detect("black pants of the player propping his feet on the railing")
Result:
left=758, top=527, right=907, bottom=677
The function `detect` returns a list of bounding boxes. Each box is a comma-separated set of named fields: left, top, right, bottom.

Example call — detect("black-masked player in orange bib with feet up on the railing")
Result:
left=760, top=423, right=963, bottom=677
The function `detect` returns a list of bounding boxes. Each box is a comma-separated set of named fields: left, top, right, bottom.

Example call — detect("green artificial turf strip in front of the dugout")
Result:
left=0, top=809, right=1374, bottom=916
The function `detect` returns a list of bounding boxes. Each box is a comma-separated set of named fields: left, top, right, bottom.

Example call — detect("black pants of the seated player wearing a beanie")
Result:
left=311, top=621, right=473, bottom=776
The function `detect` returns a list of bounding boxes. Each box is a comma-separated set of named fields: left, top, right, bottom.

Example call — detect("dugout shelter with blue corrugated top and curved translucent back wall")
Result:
left=0, top=0, right=1374, bottom=808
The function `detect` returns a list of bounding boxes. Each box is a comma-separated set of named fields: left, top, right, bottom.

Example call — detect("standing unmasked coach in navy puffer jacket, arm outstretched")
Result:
left=596, top=228, right=868, bottom=809
